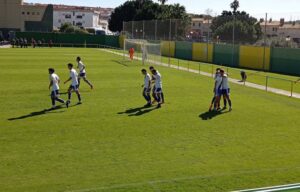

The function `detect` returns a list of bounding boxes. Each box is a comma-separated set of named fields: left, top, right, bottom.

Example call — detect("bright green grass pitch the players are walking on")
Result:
left=0, top=48, right=300, bottom=192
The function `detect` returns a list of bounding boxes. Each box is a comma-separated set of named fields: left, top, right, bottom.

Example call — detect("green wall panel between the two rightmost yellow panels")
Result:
left=213, top=44, right=239, bottom=67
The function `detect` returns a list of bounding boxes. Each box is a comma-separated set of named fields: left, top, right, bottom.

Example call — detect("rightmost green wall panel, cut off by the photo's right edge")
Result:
left=271, top=48, right=300, bottom=75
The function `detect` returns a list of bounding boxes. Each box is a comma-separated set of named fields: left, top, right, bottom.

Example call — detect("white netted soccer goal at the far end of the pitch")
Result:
left=124, top=39, right=161, bottom=65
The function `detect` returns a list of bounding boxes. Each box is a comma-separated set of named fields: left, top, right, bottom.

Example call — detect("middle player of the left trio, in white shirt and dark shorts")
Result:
left=64, top=63, right=81, bottom=107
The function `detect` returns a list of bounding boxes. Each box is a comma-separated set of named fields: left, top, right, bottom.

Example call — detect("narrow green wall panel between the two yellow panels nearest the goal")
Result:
left=175, top=41, right=193, bottom=60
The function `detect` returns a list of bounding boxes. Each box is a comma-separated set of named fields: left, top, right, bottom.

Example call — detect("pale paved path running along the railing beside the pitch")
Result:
left=99, top=49, right=300, bottom=99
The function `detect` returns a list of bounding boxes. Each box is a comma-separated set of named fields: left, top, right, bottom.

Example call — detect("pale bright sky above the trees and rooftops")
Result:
left=24, top=0, right=300, bottom=20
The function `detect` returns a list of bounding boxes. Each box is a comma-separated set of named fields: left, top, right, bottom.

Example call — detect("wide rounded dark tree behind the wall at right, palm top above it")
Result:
left=211, top=0, right=262, bottom=43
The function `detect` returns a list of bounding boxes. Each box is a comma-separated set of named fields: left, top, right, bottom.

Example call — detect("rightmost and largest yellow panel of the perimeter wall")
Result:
left=240, top=46, right=271, bottom=70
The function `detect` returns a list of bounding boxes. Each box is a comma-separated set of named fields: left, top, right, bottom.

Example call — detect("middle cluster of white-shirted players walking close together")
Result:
left=141, top=66, right=165, bottom=108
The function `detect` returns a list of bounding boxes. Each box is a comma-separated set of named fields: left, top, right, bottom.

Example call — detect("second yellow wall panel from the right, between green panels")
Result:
left=193, top=43, right=213, bottom=63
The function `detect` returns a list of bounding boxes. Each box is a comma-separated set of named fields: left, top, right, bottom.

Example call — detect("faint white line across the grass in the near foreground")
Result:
left=65, top=167, right=300, bottom=192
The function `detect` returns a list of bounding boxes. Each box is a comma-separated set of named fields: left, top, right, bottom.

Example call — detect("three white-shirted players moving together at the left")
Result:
left=48, top=57, right=93, bottom=109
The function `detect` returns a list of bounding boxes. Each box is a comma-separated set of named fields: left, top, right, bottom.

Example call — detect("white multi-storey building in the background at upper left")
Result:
left=53, top=5, right=100, bottom=28
